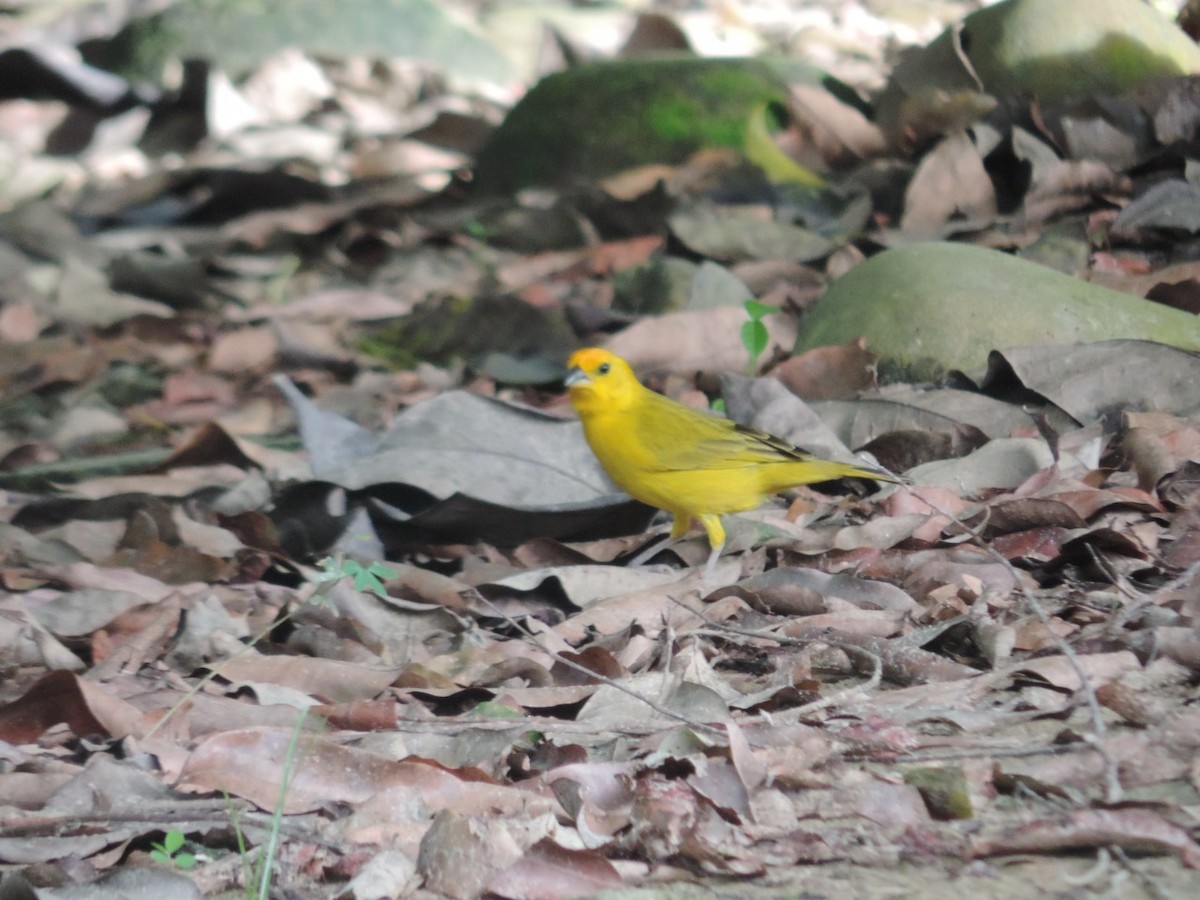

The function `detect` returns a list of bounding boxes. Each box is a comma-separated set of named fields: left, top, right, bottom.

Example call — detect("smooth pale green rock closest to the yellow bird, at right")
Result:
left=796, top=242, right=1200, bottom=380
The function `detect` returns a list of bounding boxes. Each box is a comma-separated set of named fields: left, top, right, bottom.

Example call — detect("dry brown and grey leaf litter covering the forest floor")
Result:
left=0, top=5, right=1200, bottom=898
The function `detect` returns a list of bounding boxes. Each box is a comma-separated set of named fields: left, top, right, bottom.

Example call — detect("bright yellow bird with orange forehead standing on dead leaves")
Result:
left=565, top=347, right=900, bottom=572
